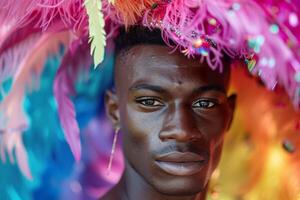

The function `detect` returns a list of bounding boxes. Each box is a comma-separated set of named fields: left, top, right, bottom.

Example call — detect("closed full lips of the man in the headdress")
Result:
left=155, top=152, right=207, bottom=176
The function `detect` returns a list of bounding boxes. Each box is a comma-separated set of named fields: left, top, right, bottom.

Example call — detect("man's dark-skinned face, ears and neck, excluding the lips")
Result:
left=102, top=45, right=235, bottom=200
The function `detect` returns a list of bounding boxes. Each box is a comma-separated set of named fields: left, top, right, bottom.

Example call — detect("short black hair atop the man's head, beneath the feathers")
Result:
left=115, top=25, right=166, bottom=56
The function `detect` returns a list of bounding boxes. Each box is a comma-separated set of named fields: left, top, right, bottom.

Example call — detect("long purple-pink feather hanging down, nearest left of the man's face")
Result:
left=54, top=41, right=91, bottom=161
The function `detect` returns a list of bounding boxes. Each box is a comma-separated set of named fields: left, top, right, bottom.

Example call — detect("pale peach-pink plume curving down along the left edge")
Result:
left=0, top=32, right=70, bottom=177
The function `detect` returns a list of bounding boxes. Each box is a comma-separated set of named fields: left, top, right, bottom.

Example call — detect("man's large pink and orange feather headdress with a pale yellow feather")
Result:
left=0, top=0, right=300, bottom=178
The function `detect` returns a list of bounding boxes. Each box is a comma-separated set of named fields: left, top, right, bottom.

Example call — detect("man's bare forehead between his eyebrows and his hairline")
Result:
left=115, top=45, right=229, bottom=89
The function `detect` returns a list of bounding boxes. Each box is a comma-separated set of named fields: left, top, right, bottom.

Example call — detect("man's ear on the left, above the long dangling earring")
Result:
left=105, top=90, right=120, bottom=127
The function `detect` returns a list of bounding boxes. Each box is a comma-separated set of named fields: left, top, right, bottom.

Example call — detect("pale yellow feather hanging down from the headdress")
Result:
left=84, top=0, right=106, bottom=68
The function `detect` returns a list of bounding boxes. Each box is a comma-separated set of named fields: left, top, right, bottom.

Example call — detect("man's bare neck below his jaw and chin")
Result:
left=116, top=162, right=207, bottom=200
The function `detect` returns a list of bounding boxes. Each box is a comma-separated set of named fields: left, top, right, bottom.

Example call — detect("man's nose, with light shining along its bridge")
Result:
left=159, top=102, right=202, bottom=142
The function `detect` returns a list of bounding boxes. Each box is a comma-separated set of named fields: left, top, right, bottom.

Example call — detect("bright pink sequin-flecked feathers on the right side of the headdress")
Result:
left=143, top=0, right=300, bottom=107
